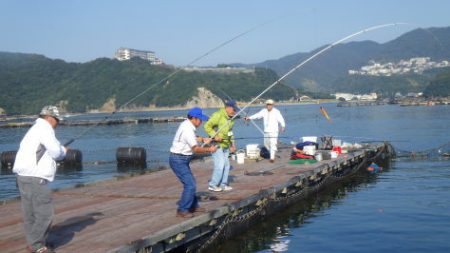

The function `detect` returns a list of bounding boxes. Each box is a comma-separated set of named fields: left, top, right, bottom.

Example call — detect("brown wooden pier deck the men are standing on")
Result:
left=0, top=144, right=384, bottom=253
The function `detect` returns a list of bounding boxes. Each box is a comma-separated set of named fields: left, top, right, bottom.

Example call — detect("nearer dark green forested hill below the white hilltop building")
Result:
left=0, top=52, right=295, bottom=114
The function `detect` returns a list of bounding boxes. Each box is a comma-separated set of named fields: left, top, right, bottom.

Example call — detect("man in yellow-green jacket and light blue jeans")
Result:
left=204, top=100, right=238, bottom=192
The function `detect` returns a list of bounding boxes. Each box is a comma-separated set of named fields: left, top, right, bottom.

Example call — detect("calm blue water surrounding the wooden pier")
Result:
left=0, top=104, right=450, bottom=252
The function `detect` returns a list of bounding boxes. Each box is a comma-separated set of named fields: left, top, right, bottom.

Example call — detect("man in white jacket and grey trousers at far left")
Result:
left=13, top=106, right=67, bottom=253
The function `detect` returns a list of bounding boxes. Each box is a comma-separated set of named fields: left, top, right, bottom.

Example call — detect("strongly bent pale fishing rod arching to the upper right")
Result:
left=212, top=23, right=407, bottom=138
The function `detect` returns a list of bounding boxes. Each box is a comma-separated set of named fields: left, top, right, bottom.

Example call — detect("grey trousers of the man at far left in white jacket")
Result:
left=17, top=176, right=53, bottom=249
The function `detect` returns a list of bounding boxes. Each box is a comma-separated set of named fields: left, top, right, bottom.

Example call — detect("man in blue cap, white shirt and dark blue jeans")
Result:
left=169, top=107, right=217, bottom=218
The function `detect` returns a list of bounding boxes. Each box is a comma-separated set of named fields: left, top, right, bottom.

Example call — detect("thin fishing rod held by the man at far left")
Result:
left=59, top=17, right=280, bottom=147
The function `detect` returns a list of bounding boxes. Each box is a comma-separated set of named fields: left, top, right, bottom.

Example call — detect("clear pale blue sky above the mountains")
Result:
left=0, top=0, right=450, bottom=66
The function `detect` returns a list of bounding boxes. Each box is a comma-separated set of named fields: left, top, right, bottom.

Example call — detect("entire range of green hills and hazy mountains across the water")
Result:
left=0, top=27, right=450, bottom=114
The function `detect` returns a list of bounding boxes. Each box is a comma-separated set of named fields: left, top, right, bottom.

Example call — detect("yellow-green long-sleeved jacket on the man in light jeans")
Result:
left=204, top=108, right=234, bottom=148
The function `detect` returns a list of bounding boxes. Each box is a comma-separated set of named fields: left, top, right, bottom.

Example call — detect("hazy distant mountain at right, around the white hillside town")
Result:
left=236, top=27, right=450, bottom=93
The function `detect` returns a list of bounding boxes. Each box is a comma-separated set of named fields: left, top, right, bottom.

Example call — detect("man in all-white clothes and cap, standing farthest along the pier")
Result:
left=244, top=99, right=286, bottom=163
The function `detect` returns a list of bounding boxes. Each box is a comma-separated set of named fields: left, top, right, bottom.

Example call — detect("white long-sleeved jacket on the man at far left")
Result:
left=13, top=118, right=66, bottom=182
